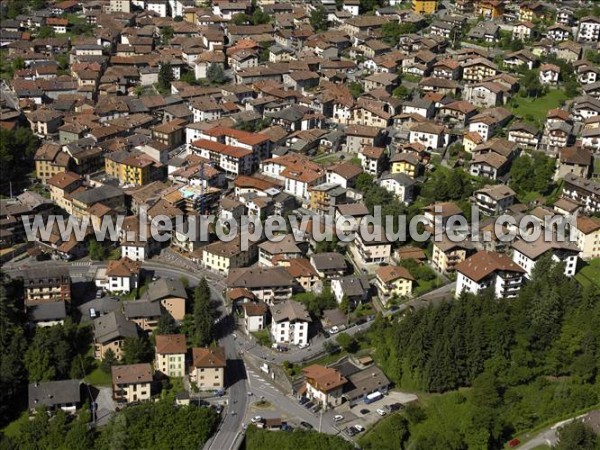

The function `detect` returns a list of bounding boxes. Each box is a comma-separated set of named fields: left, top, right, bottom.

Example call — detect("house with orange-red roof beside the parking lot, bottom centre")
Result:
left=302, top=364, right=348, bottom=409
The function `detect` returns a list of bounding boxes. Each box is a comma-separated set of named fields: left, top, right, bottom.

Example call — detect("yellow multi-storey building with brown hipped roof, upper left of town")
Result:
left=104, top=151, right=164, bottom=186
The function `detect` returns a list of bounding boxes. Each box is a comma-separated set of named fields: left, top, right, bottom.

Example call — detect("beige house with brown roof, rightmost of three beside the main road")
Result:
left=190, top=347, right=227, bottom=391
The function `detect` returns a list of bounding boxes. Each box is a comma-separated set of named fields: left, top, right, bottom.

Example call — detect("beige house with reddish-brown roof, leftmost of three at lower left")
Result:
left=112, top=363, right=152, bottom=403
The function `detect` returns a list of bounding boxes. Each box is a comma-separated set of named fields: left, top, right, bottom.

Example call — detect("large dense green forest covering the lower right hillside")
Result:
left=364, top=255, right=600, bottom=449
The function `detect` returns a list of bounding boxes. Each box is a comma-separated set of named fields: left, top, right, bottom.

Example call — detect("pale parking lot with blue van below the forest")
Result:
left=328, top=391, right=417, bottom=436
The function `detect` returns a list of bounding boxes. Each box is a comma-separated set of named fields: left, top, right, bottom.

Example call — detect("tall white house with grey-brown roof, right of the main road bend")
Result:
left=269, top=300, right=312, bottom=345
